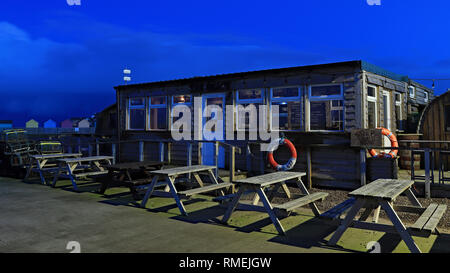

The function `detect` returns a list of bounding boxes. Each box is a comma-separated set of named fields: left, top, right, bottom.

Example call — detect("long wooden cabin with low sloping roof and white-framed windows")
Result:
left=111, top=61, right=433, bottom=188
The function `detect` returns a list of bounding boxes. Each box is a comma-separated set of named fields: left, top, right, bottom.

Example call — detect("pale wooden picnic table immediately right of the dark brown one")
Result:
left=141, top=165, right=232, bottom=215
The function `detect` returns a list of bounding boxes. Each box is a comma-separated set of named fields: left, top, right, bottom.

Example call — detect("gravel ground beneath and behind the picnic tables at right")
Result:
left=273, top=187, right=450, bottom=229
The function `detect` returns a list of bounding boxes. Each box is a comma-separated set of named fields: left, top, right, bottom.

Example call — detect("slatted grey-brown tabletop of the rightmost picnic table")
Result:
left=348, top=179, right=414, bottom=201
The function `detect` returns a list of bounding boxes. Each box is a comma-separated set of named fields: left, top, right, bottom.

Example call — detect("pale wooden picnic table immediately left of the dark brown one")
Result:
left=52, top=156, right=113, bottom=191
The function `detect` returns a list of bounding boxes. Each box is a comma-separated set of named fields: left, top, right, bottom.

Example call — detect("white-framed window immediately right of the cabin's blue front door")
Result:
left=236, top=89, right=264, bottom=130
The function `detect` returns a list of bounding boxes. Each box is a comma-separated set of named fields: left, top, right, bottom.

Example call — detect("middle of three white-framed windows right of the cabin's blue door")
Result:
left=270, top=87, right=302, bottom=130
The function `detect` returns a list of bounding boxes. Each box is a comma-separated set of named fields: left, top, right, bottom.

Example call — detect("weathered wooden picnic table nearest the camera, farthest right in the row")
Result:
left=328, top=179, right=447, bottom=253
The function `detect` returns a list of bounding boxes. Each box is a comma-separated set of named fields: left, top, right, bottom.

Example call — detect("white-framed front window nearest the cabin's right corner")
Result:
left=309, top=84, right=344, bottom=131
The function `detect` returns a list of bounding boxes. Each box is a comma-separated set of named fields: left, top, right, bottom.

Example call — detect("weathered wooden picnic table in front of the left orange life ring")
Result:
left=222, top=171, right=328, bottom=235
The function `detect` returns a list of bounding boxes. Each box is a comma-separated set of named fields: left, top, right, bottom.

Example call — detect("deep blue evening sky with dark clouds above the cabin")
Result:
left=0, top=0, right=450, bottom=126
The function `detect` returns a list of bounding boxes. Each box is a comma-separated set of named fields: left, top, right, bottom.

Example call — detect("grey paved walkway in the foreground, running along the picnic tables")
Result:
left=0, top=175, right=450, bottom=253
